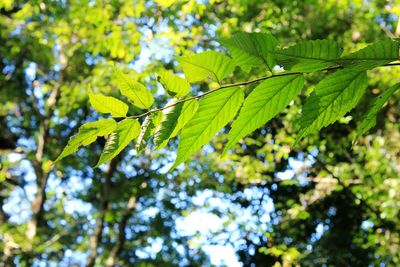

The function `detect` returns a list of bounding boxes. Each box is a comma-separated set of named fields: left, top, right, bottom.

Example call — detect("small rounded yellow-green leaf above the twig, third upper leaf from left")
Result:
left=157, top=71, right=190, bottom=98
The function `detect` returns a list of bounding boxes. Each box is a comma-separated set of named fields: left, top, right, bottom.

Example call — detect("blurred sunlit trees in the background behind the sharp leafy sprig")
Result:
left=0, top=0, right=400, bottom=266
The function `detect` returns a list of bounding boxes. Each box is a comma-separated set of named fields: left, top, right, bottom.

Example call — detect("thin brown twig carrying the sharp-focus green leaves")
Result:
left=127, top=62, right=400, bottom=119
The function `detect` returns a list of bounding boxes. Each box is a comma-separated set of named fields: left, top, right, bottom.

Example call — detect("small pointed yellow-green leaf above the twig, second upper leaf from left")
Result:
left=116, top=70, right=154, bottom=109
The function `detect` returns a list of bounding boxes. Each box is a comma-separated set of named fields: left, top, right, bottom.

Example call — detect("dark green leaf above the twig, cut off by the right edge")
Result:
left=339, top=39, right=399, bottom=71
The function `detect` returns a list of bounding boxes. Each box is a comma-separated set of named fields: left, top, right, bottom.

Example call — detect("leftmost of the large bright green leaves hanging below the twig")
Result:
left=171, top=87, right=244, bottom=169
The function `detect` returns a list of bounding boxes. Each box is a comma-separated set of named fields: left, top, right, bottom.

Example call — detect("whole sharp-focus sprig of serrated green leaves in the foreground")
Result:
left=56, top=32, right=399, bottom=169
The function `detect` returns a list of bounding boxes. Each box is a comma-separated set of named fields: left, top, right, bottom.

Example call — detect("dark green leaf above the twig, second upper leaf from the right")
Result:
left=274, top=40, right=342, bottom=72
